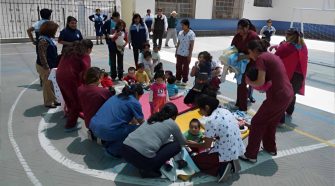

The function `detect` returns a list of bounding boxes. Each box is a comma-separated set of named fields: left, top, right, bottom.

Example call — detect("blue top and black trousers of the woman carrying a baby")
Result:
left=102, top=19, right=123, bottom=80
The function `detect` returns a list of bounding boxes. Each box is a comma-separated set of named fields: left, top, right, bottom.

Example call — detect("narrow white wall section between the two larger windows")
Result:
left=195, top=0, right=213, bottom=19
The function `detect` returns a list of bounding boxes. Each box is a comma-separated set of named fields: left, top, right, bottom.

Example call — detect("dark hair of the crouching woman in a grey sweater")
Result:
left=148, top=103, right=178, bottom=124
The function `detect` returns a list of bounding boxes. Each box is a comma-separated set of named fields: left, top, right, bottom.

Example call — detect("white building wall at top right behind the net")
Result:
left=243, top=0, right=335, bottom=25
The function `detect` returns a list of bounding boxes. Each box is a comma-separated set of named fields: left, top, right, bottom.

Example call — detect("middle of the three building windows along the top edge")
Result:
left=212, top=0, right=243, bottom=19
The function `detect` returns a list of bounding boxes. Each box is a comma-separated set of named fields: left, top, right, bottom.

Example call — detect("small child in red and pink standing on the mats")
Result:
left=149, top=72, right=169, bottom=114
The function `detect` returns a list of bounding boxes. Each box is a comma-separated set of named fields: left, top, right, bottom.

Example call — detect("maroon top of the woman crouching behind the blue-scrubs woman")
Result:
left=78, top=85, right=112, bottom=128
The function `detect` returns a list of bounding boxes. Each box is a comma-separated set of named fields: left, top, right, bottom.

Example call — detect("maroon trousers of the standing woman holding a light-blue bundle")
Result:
left=235, top=74, right=248, bottom=111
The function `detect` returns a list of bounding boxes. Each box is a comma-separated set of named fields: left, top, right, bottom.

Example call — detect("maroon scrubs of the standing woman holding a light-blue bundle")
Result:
left=231, top=30, right=260, bottom=111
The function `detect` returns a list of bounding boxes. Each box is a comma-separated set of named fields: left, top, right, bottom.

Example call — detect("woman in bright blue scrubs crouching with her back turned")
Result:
left=89, top=84, right=144, bottom=157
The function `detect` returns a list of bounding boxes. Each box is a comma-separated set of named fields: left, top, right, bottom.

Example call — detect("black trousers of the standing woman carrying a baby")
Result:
left=108, top=44, right=123, bottom=79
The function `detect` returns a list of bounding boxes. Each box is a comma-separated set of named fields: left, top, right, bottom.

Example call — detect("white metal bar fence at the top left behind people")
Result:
left=0, top=0, right=116, bottom=39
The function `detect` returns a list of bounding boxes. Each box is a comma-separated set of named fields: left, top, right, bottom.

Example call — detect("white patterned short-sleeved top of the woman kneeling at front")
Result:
left=204, top=107, right=245, bottom=162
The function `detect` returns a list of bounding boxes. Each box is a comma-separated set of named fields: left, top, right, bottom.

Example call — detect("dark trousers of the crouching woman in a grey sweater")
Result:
left=121, top=142, right=181, bottom=171
